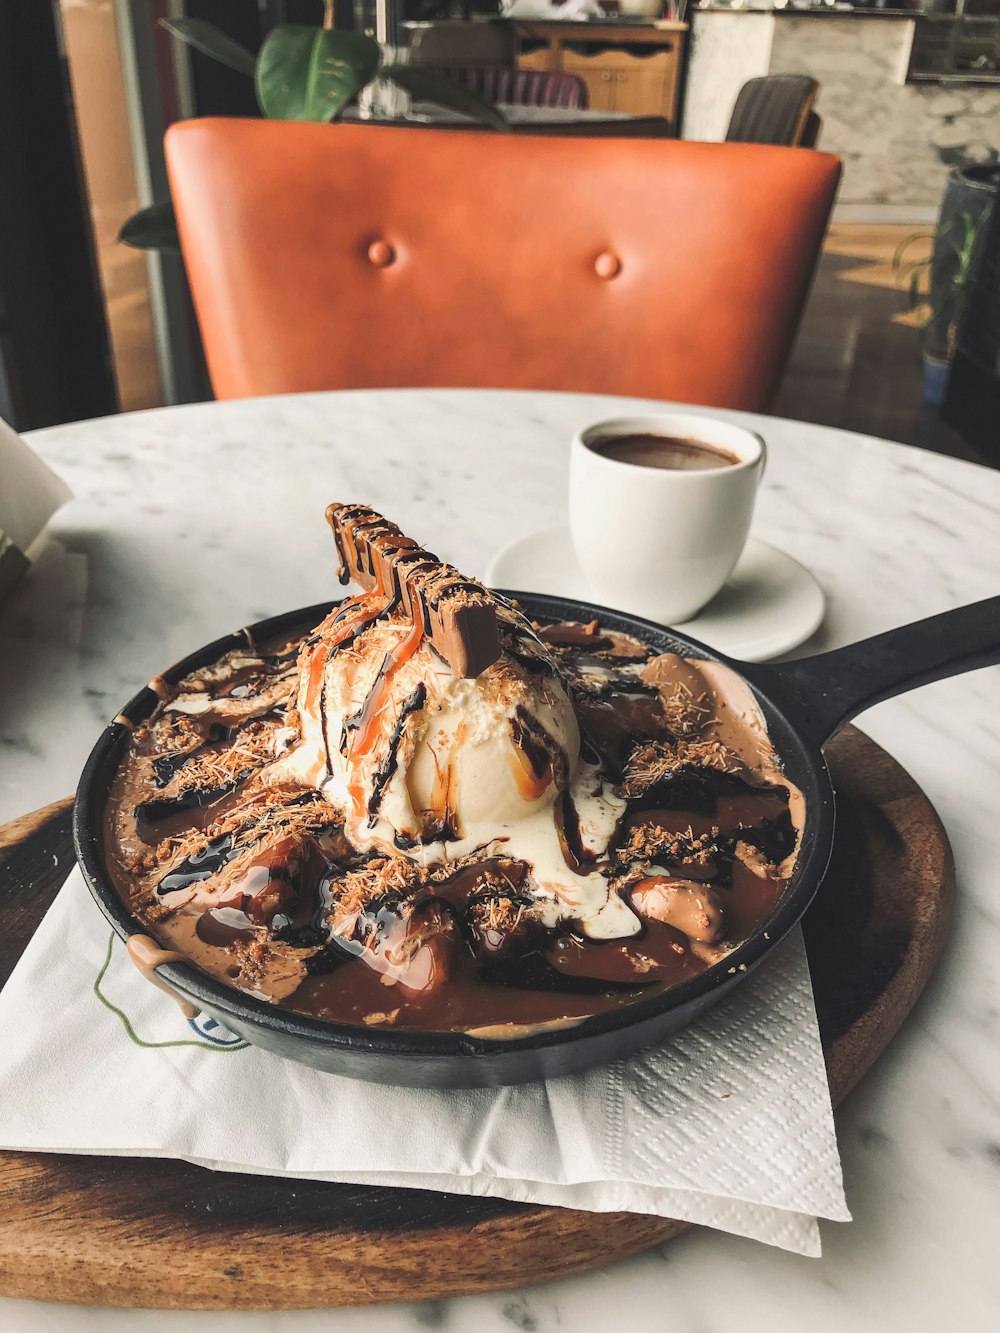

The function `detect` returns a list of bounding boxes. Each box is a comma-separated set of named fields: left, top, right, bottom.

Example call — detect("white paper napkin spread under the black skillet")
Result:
left=0, top=870, right=849, bottom=1254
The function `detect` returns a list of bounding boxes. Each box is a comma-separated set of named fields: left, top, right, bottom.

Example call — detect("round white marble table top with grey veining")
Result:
left=0, top=391, right=1000, bottom=1333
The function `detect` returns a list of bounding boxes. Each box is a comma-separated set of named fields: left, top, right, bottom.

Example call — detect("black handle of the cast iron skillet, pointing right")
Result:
left=741, top=597, right=1000, bottom=746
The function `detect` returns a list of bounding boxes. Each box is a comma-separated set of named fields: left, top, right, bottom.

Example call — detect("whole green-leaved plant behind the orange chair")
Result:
left=119, top=0, right=511, bottom=255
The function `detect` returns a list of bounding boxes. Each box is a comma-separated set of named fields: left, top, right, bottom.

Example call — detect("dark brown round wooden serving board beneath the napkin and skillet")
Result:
left=0, top=728, right=955, bottom=1309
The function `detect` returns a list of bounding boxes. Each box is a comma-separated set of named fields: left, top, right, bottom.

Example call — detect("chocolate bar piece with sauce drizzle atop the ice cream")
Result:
left=327, top=504, right=500, bottom=676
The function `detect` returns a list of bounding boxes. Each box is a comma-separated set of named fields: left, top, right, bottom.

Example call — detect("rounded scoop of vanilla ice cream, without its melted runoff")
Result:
left=320, top=621, right=580, bottom=845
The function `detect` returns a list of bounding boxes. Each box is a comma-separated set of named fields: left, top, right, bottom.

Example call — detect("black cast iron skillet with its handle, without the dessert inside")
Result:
left=73, top=593, right=1000, bottom=1088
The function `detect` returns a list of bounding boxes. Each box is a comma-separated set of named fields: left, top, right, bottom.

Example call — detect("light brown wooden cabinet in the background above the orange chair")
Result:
left=516, top=21, right=688, bottom=125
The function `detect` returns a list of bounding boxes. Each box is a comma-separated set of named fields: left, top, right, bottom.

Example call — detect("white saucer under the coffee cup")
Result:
left=485, top=527, right=824, bottom=663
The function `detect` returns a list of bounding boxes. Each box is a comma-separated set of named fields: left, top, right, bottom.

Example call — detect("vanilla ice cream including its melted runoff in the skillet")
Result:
left=275, top=605, right=640, bottom=936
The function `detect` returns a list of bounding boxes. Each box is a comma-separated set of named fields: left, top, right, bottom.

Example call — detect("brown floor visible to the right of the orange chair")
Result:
left=777, top=223, right=1000, bottom=467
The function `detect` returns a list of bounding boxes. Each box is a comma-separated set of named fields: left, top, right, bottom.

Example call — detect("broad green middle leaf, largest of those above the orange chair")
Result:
left=257, top=24, right=381, bottom=120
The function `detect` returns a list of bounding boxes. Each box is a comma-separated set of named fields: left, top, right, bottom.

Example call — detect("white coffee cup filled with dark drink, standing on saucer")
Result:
left=569, top=412, right=765, bottom=624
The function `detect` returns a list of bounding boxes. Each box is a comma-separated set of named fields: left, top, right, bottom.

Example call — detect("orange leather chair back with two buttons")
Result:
left=167, top=119, right=840, bottom=409
